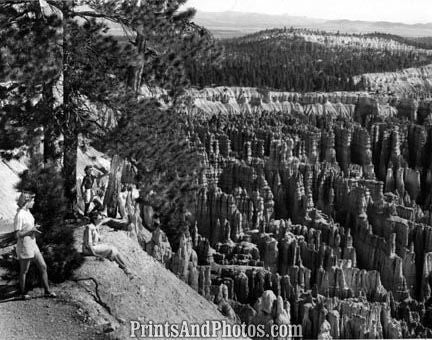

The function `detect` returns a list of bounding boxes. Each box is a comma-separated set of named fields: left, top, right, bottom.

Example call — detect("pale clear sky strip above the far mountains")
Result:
left=186, top=0, right=432, bottom=24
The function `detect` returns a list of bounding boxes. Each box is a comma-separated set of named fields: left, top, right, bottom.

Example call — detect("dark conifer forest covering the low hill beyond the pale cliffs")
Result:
left=187, top=29, right=432, bottom=92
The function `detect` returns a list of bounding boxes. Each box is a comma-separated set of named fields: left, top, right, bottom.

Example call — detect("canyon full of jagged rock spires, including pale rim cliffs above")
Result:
left=160, top=84, right=432, bottom=339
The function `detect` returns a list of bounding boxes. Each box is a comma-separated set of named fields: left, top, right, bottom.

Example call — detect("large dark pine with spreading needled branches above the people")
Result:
left=0, top=0, right=218, bottom=209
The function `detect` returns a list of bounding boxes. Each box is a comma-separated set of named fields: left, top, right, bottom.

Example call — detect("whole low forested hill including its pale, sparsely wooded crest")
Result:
left=187, top=27, right=432, bottom=95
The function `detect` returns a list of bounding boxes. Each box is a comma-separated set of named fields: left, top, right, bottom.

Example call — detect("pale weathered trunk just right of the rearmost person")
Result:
left=104, top=155, right=124, bottom=218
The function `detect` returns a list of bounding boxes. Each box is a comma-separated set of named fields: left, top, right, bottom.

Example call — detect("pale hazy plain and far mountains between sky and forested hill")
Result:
left=194, top=11, right=432, bottom=38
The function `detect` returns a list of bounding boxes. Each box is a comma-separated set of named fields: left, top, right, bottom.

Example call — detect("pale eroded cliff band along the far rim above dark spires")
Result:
left=186, top=83, right=432, bottom=122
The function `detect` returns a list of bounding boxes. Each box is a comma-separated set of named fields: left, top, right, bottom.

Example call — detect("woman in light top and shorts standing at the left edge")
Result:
left=14, top=192, right=56, bottom=299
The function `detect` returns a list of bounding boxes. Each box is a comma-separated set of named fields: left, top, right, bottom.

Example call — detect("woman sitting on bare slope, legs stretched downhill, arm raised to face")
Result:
left=82, top=212, right=132, bottom=275
